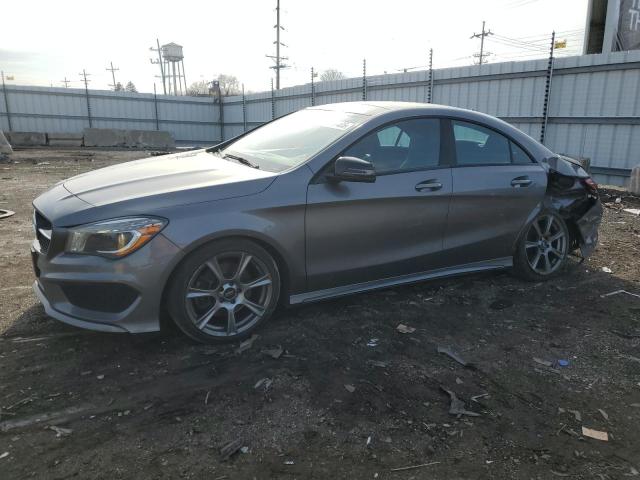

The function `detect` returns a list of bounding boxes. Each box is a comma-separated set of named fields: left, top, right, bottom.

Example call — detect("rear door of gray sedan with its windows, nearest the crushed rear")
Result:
left=444, top=120, right=547, bottom=264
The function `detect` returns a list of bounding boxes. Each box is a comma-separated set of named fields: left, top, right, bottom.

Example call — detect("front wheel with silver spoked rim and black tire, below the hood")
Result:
left=167, top=239, right=280, bottom=343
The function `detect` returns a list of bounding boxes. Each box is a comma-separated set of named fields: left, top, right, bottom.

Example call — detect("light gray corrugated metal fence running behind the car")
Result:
left=0, top=51, right=640, bottom=184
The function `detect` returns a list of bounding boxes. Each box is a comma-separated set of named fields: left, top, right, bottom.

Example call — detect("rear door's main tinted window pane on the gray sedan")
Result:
left=452, top=121, right=511, bottom=165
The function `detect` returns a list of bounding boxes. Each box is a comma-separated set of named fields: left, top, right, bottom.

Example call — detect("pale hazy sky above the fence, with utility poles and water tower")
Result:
left=0, top=0, right=587, bottom=92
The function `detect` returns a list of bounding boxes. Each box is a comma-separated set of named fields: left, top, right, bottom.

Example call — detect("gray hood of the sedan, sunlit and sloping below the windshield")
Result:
left=63, top=150, right=275, bottom=207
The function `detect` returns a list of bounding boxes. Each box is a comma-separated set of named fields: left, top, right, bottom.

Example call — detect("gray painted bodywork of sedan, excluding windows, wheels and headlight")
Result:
left=32, top=102, right=598, bottom=332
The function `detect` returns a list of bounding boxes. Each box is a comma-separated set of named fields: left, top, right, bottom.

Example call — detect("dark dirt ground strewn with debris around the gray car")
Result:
left=0, top=150, right=640, bottom=480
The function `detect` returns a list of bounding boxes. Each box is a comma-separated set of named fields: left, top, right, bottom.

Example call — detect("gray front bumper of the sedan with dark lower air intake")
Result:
left=31, top=234, right=183, bottom=333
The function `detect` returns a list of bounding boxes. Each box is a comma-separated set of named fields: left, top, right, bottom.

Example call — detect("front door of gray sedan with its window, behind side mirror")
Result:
left=306, top=118, right=451, bottom=291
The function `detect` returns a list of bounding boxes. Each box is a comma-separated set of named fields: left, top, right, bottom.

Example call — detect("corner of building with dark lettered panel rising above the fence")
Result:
left=584, top=0, right=640, bottom=54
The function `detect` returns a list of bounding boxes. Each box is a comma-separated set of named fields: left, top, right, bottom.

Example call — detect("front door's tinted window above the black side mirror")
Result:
left=342, top=118, right=440, bottom=174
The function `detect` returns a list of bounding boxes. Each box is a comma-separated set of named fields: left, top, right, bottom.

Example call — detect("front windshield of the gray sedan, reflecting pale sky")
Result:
left=216, top=109, right=367, bottom=172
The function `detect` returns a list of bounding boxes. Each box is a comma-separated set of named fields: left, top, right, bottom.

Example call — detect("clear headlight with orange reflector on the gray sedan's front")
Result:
left=65, top=217, right=167, bottom=258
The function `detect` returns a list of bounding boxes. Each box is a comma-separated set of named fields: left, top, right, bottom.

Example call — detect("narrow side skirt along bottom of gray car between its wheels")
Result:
left=289, top=257, right=513, bottom=305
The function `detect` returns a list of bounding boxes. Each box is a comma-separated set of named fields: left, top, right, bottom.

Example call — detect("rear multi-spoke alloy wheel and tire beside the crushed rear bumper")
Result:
left=514, top=212, right=570, bottom=281
